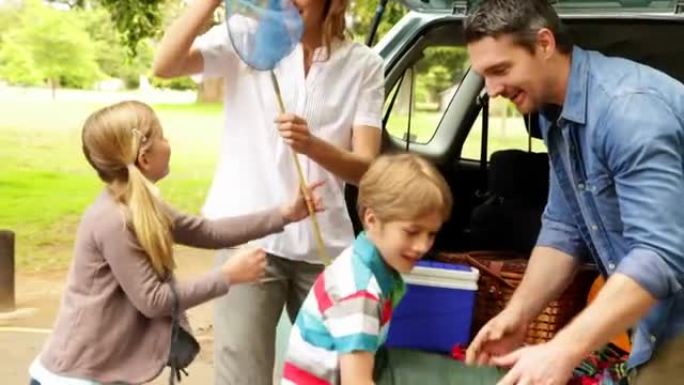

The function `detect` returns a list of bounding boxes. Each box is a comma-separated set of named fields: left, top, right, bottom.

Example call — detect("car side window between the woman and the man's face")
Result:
left=385, top=46, right=468, bottom=144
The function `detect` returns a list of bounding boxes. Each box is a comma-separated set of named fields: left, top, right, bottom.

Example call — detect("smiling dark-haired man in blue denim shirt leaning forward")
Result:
left=465, top=0, right=684, bottom=385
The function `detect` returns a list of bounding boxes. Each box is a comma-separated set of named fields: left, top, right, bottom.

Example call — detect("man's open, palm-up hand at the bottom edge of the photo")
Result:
left=491, top=341, right=581, bottom=385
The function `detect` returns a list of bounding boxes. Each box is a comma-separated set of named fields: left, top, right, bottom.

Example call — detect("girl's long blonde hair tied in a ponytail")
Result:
left=82, top=101, right=175, bottom=277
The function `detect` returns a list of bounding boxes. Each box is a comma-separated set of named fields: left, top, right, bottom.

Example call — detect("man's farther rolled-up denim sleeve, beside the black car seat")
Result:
left=537, top=167, right=587, bottom=261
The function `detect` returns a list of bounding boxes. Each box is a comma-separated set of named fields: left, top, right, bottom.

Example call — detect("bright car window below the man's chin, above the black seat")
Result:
left=461, top=97, right=546, bottom=160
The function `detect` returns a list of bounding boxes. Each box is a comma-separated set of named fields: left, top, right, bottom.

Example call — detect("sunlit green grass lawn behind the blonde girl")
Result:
left=0, top=101, right=222, bottom=271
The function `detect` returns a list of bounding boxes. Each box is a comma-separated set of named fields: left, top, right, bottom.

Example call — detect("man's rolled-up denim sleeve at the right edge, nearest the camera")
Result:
left=597, top=93, right=684, bottom=299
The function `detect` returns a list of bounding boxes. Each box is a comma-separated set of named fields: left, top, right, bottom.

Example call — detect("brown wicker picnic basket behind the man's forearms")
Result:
left=437, top=251, right=597, bottom=344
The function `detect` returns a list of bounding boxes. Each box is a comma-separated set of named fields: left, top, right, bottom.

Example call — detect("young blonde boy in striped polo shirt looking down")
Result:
left=282, top=154, right=452, bottom=385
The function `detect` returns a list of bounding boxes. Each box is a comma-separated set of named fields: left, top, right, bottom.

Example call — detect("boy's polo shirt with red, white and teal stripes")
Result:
left=281, top=233, right=405, bottom=385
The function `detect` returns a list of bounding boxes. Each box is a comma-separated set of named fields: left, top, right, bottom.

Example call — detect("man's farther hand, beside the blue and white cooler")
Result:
left=466, top=308, right=527, bottom=365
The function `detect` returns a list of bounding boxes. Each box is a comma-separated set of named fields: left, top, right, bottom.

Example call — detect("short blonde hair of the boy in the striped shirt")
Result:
left=358, top=154, right=452, bottom=222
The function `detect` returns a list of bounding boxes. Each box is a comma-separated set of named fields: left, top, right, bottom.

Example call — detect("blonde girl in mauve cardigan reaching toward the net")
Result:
left=30, top=101, right=321, bottom=385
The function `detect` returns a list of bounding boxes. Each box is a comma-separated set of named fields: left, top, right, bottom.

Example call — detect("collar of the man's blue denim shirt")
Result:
left=542, top=46, right=589, bottom=124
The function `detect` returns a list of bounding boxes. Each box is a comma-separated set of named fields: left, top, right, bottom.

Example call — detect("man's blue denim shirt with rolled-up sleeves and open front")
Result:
left=537, top=47, right=684, bottom=367
